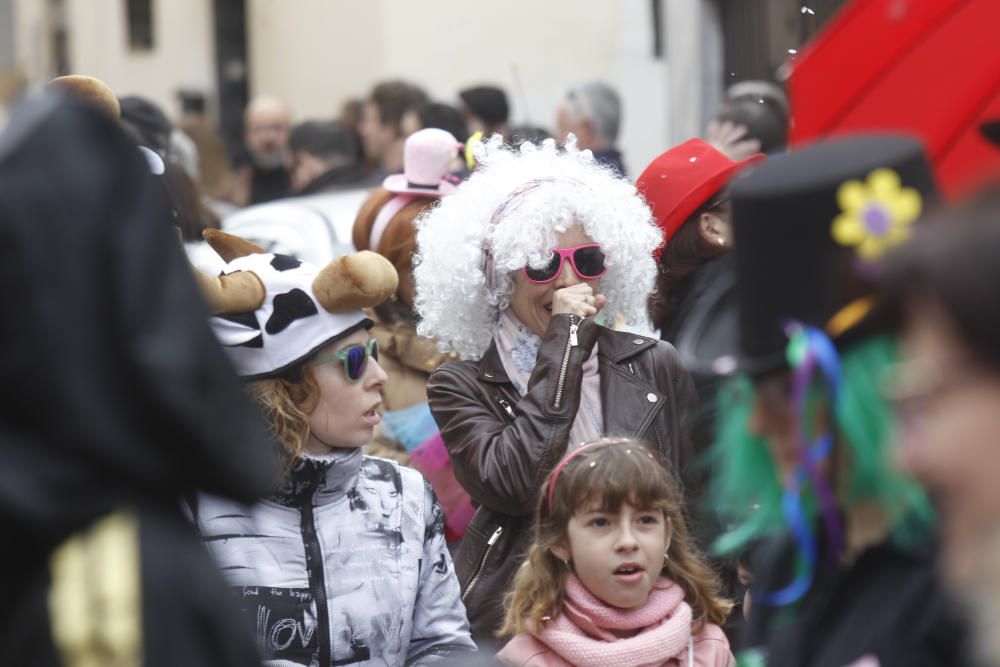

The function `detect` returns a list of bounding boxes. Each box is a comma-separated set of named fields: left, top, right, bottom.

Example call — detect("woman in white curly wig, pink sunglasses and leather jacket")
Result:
left=415, top=137, right=697, bottom=646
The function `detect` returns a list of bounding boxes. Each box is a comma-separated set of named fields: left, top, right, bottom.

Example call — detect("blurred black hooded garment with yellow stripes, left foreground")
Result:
left=0, top=97, right=274, bottom=667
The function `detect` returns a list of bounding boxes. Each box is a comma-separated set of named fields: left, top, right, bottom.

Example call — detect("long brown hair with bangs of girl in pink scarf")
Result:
left=499, top=438, right=732, bottom=636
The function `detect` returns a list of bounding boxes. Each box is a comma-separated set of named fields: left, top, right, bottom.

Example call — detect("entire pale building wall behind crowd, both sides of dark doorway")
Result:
left=13, top=0, right=705, bottom=177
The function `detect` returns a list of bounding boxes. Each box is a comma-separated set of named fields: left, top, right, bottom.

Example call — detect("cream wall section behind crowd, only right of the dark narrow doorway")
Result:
left=248, top=0, right=674, bottom=176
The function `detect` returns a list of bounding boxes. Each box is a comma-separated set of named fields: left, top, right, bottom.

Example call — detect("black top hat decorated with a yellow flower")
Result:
left=677, top=134, right=936, bottom=375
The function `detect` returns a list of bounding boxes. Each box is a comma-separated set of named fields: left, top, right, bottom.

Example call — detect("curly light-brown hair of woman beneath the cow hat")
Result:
left=249, top=363, right=319, bottom=465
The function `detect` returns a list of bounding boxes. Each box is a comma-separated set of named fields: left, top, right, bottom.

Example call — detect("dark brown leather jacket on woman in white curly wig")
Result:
left=427, top=315, right=697, bottom=646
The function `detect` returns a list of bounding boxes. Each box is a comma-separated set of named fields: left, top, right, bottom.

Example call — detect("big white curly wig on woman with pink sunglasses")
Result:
left=413, top=135, right=662, bottom=359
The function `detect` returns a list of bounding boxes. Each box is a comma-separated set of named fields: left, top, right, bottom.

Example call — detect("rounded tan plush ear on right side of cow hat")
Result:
left=312, top=250, right=399, bottom=313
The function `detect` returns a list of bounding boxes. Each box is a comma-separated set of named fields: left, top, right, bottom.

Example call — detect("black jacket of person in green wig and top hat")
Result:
left=743, top=535, right=969, bottom=667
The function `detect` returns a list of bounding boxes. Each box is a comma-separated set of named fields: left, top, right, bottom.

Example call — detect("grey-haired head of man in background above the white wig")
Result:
left=556, top=81, right=625, bottom=176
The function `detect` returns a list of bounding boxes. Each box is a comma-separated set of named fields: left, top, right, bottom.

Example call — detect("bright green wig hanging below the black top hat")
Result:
left=707, top=336, right=934, bottom=554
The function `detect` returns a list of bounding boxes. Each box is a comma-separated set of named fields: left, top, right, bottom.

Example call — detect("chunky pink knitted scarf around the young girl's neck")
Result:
left=538, top=574, right=691, bottom=667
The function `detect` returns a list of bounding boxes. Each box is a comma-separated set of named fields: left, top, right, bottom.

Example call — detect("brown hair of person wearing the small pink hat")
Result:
left=352, top=187, right=437, bottom=313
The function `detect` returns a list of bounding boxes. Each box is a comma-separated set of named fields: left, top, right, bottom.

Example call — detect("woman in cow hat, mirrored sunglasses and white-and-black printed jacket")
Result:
left=192, top=232, right=475, bottom=665
